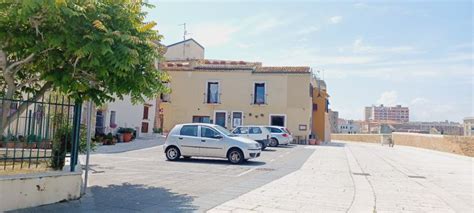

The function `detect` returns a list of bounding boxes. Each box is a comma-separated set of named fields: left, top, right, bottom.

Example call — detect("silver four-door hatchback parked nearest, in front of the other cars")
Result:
left=163, top=123, right=261, bottom=164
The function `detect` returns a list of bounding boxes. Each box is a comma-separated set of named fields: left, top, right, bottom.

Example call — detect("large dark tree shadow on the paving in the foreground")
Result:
left=11, top=183, right=198, bottom=213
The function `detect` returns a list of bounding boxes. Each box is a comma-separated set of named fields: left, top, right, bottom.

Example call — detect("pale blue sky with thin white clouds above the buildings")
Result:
left=147, top=0, right=474, bottom=122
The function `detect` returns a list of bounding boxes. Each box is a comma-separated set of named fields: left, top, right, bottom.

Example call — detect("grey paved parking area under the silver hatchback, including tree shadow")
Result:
left=15, top=139, right=315, bottom=212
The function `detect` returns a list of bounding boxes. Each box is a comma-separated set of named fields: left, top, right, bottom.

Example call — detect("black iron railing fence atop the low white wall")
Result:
left=0, top=94, right=81, bottom=171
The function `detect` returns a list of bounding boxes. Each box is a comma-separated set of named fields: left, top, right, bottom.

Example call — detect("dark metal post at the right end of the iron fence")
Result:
left=70, top=101, right=82, bottom=172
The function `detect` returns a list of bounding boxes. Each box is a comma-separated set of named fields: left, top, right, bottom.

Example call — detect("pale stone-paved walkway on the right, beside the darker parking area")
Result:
left=209, top=142, right=474, bottom=213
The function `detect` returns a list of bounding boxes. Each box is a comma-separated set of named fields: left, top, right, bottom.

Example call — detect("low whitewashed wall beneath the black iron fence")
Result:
left=0, top=167, right=82, bottom=212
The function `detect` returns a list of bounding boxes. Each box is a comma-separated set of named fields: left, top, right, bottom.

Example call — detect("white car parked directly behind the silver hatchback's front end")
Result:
left=232, top=126, right=271, bottom=150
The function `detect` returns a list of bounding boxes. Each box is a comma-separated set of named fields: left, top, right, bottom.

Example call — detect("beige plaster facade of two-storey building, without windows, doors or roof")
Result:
left=161, top=70, right=312, bottom=137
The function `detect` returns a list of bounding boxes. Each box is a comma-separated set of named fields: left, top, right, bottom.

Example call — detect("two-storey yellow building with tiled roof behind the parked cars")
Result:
left=160, top=59, right=325, bottom=141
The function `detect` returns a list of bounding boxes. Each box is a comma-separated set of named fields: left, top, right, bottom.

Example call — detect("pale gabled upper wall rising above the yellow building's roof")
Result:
left=164, top=39, right=204, bottom=61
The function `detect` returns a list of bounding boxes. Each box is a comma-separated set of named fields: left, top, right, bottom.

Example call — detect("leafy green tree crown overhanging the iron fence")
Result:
left=0, top=0, right=167, bottom=132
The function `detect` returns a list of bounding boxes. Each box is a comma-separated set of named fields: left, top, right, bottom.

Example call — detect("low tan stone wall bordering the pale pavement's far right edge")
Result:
left=331, top=132, right=474, bottom=157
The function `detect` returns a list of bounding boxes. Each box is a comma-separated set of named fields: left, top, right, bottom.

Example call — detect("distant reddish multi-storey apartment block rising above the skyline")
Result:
left=365, top=105, right=410, bottom=123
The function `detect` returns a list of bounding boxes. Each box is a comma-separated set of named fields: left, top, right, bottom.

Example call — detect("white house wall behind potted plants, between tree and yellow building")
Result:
left=104, top=96, right=156, bottom=136
